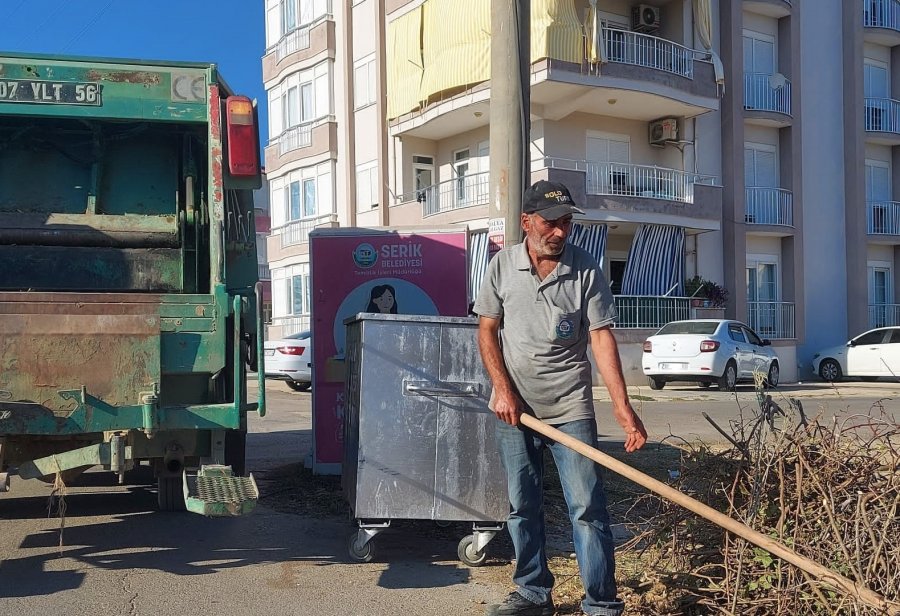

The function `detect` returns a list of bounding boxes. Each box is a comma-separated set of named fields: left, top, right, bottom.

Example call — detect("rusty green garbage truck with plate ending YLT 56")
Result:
left=0, top=52, right=265, bottom=515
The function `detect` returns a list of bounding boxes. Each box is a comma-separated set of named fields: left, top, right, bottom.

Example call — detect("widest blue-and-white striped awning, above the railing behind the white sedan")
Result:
left=622, top=225, right=684, bottom=296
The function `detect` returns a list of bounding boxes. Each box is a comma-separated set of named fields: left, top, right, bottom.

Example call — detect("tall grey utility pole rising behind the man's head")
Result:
left=488, top=0, right=531, bottom=252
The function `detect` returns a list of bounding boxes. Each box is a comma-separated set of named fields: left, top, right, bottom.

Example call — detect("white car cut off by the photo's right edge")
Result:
left=813, top=327, right=900, bottom=381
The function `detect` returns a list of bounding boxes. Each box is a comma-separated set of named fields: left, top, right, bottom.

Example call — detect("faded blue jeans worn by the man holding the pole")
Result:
left=497, top=419, right=625, bottom=616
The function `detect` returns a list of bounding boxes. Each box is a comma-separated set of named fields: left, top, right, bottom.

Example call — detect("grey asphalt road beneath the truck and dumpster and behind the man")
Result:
left=0, top=382, right=900, bottom=616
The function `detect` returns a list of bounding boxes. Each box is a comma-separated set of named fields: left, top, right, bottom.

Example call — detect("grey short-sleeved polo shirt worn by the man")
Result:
left=474, top=242, right=616, bottom=424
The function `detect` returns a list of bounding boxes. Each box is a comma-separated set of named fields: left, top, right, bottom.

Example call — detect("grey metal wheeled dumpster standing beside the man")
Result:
left=343, top=313, right=509, bottom=566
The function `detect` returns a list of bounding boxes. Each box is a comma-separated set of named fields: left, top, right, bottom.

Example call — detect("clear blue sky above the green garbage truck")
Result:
left=0, top=0, right=268, bottom=138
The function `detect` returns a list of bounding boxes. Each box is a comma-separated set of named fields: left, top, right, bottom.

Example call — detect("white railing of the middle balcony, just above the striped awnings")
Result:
left=584, top=162, right=716, bottom=203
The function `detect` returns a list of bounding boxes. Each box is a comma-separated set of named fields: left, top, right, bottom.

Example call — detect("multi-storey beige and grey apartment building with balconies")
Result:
left=263, top=0, right=900, bottom=383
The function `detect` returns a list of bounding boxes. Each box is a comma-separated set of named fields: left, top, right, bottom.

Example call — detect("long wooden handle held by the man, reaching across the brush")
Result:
left=519, top=413, right=900, bottom=616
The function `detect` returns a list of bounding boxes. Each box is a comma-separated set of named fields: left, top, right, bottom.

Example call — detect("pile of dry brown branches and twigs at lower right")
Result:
left=620, top=390, right=900, bottom=616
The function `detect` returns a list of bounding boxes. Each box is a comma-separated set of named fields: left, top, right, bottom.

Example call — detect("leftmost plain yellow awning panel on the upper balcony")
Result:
left=385, top=6, right=424, bottom=118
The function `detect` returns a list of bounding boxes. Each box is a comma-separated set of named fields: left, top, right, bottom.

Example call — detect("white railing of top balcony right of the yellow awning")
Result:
left=603, top=28, right=695, bottom=79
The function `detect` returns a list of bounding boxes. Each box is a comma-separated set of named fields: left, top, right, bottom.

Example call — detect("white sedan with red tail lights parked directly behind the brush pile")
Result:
left=641, top=319, right=779, bottom=391
